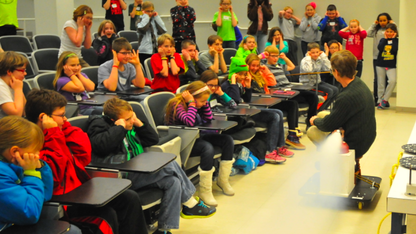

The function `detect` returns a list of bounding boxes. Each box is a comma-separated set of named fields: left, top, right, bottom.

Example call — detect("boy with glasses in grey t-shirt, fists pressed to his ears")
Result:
left=97, top=37, right=151, bottom=92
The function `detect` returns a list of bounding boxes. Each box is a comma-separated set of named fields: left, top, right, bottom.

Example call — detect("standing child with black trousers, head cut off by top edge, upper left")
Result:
left=101, top=0, right=127, bottom=32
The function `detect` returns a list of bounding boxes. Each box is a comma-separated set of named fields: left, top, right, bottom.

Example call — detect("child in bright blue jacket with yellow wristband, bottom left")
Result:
left=0, top=116, right=53, bottom=230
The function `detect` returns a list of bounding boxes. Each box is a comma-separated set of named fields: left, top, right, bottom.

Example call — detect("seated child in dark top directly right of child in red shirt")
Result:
left=179, top=40, right=207, bottom=86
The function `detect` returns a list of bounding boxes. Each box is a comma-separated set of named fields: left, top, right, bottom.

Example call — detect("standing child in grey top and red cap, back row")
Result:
left=299, top=2, right=322, bottom=55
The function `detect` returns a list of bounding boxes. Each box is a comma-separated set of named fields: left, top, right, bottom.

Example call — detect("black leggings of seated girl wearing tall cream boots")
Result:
left=191, top=133, right=234, bottom=171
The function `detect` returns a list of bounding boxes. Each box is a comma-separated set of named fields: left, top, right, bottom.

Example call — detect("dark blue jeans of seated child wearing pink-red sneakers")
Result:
left=251, top=108, right=285, bottom=152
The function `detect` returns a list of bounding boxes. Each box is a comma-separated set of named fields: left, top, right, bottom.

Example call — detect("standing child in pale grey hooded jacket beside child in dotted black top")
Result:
left=137, top=1, right=167, bottom=64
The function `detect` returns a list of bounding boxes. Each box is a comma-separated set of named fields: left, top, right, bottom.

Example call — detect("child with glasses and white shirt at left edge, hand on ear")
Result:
left=0, top=51, right=29, bottom=119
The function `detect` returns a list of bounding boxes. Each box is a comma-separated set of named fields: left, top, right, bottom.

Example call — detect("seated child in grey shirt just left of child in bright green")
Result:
left=200, top=35, right=227, bottom=75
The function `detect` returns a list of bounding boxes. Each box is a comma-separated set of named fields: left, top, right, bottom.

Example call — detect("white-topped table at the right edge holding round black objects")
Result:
left=387, top=121, right=416, bottom=234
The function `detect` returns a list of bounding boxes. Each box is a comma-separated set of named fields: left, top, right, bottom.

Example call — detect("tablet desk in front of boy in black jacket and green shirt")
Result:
left=88, top=152, right=176, bottom=173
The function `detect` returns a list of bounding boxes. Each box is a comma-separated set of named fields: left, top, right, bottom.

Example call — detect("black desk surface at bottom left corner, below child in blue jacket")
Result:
left=1, top=219, right=70, bottom=234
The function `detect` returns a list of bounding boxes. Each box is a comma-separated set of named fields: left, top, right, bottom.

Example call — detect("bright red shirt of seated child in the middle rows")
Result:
left=150, top=53, right=185, bottom=93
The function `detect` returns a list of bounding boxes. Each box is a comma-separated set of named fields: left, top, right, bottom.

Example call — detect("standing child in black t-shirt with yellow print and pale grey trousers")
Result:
left=376, top=24, right=399, bottom=109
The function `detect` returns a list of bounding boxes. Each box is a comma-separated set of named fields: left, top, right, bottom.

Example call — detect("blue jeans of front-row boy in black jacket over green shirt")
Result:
left=128, top=161, right=195, bottom=229
